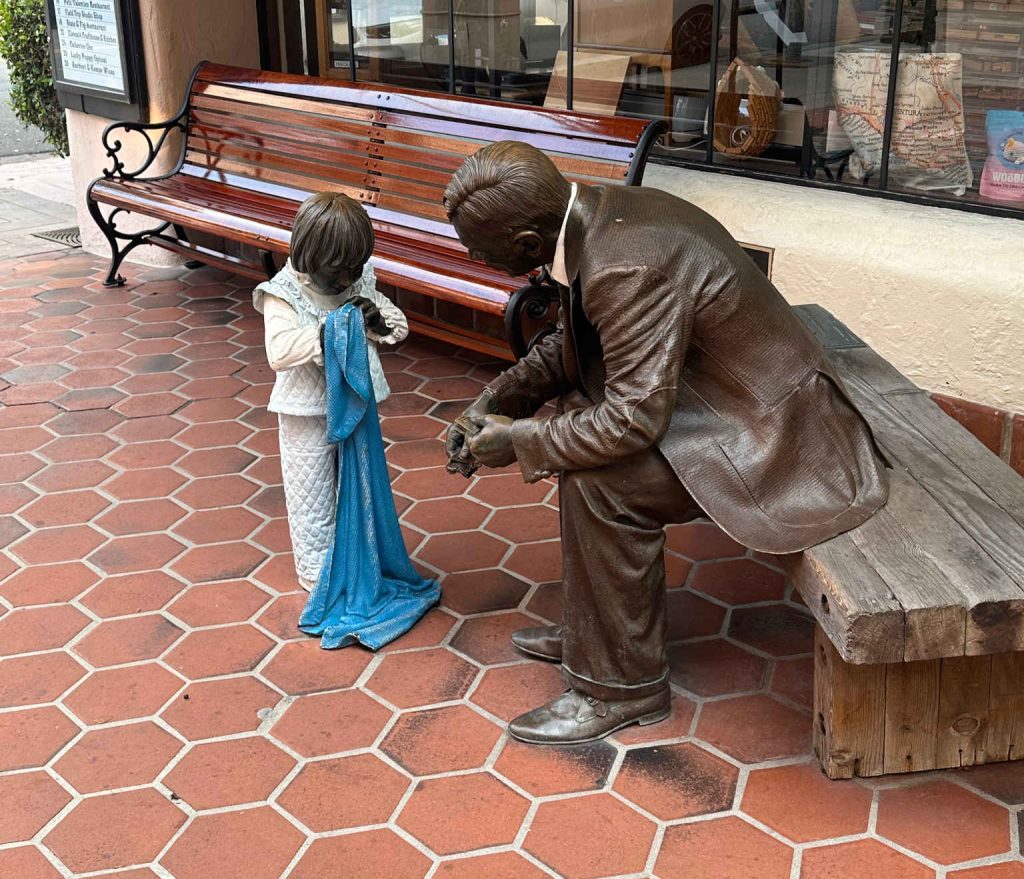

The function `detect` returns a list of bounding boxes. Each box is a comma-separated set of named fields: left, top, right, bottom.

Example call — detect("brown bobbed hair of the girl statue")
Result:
left=289, top=193, right=374, bottom=275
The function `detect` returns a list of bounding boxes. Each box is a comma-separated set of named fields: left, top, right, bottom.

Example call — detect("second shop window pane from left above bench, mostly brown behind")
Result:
left=453, top=0, right=568, bottom=106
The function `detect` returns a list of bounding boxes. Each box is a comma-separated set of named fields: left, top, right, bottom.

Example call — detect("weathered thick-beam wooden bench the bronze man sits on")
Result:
left=785, top=305, right=1024, bottom=779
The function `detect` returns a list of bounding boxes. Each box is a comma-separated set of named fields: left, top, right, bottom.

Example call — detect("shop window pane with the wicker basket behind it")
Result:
left=700, top=0, right=921, bottom=186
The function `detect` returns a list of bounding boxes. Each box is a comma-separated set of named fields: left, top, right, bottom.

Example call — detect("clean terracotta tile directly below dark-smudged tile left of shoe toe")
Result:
left=398, top=772, right=529, bottom=854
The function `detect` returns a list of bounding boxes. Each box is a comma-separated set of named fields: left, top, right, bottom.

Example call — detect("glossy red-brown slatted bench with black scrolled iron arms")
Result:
left=88, top=64, right=664, bottom=359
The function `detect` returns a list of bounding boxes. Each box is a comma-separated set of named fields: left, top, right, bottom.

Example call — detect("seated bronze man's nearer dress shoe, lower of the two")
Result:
left=509, top=686, right=672, bottom=745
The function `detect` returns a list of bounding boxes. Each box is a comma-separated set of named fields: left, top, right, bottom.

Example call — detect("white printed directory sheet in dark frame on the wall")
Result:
left=52, top=0, right=127, bottom=99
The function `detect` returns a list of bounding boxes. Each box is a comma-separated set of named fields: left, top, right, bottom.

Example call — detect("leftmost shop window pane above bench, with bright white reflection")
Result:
left=352, top=0, right=449, bottom=91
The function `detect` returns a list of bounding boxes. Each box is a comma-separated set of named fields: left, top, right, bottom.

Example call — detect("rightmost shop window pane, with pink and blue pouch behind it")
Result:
left=890, top=0, right=1024, bottom=207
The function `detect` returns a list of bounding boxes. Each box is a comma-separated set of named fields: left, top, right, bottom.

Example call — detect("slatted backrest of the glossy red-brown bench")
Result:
left=181, top=64, right=660, bottom=238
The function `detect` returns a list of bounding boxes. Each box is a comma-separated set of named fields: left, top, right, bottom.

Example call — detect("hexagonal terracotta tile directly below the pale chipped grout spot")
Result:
left=164, top=736, right=295, bottom=810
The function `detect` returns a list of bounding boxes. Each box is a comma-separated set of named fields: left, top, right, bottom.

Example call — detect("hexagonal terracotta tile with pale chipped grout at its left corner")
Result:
left=270, top=689, right=391, bottom=757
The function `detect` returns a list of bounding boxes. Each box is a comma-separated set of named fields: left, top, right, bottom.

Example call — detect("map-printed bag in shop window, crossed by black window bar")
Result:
left=833, top=51, right=974, bottom=196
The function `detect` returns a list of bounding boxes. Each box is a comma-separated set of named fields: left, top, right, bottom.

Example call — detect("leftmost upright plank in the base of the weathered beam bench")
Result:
left=814, top=626, right=888, bottom=779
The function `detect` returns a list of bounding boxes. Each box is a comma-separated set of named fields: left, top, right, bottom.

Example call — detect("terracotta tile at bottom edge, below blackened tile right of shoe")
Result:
left=654, top=818, right=790, bottom=879
